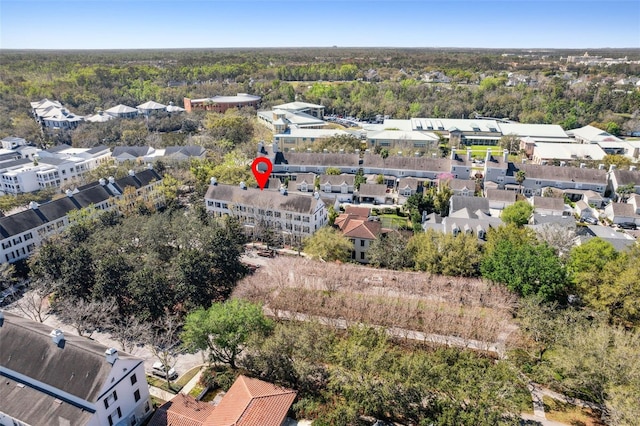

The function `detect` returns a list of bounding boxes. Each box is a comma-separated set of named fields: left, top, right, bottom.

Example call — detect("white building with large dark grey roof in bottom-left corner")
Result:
left=0, top=311, right=151, bottom=426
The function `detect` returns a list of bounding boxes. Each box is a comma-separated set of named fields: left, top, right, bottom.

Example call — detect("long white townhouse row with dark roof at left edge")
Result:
left=0, top=169, right=164, bottom=263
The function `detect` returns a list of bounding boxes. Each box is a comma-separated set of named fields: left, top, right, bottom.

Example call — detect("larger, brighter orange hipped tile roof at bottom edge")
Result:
left=204, top=376, right=296, bottom=426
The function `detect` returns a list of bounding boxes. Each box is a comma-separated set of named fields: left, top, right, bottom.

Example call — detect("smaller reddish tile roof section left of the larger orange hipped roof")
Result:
left=149, top=393, right=215, bottom=426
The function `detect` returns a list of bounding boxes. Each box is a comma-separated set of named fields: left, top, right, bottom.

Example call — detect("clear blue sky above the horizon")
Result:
left=0, top=0, right=640, bottom=49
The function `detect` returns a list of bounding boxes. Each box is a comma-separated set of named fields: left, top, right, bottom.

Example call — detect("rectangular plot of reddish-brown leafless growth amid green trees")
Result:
left=235, top=258, right=515, bottom=348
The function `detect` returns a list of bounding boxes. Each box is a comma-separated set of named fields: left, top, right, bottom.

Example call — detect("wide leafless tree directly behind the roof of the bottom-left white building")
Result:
left=54, top=298, right=118, bottom=337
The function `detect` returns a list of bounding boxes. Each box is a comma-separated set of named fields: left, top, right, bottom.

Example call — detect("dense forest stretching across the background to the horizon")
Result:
left=0, top=49, right=640, bottom=144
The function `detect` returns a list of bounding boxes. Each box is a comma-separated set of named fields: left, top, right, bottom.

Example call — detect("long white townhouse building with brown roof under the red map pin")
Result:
left=204, top=179, right=327, bottom=241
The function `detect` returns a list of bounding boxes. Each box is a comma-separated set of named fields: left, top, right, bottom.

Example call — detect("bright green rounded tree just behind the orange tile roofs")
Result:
left=182, top=299, right=273, bottom=369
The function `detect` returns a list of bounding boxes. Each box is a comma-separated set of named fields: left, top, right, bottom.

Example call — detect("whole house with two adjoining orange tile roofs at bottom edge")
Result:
left=149, top=375, right=297, bottom=426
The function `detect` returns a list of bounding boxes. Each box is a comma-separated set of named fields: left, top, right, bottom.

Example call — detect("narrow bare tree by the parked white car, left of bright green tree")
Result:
left=149, top=314, right=184, bottom=389
